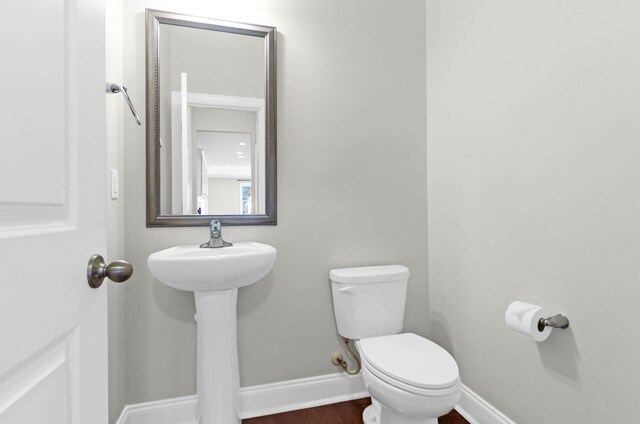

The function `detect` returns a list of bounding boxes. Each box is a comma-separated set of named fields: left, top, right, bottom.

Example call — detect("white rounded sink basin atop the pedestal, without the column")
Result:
left=147, top=242, right=277, bottom=292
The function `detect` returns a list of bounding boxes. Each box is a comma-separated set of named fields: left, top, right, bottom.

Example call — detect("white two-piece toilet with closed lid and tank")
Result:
left=329, top=265, right=460, bottom=424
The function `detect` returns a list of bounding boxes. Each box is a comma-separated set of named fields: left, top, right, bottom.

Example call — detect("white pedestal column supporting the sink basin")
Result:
left=194, top=289, right=241, bottom=424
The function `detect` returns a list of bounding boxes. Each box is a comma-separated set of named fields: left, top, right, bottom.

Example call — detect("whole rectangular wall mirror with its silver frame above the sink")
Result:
left=146, top=9, right=276, bottom=227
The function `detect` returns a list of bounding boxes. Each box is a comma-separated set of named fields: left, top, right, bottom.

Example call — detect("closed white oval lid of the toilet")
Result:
left=360, top=333, right=459, bottom=389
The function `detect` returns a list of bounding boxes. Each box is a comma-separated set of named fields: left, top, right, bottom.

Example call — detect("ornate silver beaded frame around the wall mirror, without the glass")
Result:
left=146, top=9, right=277, bottom=227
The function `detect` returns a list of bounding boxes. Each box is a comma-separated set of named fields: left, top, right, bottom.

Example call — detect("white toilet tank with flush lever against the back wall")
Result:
left=329, top=265, right=409, bottom=339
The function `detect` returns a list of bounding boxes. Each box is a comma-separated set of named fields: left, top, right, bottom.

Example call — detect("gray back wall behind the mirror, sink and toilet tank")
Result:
left=110, top=0, right=429, bottom=419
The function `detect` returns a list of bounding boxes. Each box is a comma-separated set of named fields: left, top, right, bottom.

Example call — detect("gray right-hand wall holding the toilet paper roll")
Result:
left=427, top=0, right=640, bottom=424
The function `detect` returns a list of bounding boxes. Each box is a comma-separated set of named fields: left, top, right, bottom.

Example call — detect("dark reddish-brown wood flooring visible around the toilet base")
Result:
left=242, top=398, right=469, bottom=424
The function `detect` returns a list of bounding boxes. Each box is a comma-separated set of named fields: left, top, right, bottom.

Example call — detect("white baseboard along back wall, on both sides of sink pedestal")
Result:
left=116, top=373, right=369, bottom=424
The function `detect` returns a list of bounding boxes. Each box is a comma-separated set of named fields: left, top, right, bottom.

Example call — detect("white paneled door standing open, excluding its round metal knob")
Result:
left=0, top=0, right=107, bottom=424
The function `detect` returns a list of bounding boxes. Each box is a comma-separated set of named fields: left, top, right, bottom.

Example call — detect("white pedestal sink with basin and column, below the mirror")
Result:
left=147, top=242, right=277, bottom=424
